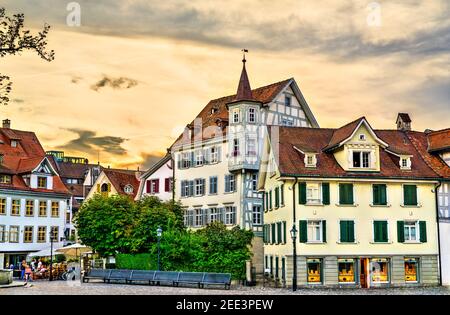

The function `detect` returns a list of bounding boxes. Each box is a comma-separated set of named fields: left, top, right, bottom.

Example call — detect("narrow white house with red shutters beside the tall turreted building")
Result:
left=135, top=154, right=174, bottom=201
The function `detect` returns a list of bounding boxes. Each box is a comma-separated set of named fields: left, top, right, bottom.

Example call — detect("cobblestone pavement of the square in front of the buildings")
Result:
left=0, top=281, right=450, bottom=295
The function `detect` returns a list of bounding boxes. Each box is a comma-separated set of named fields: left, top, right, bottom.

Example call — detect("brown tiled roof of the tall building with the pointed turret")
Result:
left=172, top=78, right=293, bottom=146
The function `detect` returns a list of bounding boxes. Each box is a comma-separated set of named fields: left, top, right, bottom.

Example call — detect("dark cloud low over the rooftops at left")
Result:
left=61, top=129, right=127, bottom=155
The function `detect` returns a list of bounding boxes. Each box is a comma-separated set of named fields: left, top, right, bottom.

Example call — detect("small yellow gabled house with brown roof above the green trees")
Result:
left=86, top=168, right=141, bottom=200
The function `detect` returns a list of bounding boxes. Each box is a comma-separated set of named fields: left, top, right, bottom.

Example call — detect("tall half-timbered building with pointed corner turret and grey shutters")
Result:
left=171, top=57, right=318, bottom=273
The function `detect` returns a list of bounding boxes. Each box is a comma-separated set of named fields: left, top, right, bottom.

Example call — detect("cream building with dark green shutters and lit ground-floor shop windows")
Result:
left=259, top=117, right=440, bottom=288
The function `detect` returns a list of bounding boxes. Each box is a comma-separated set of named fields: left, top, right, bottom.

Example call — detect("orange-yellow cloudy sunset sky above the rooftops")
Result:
left=0, top=0, right=450, bottom=169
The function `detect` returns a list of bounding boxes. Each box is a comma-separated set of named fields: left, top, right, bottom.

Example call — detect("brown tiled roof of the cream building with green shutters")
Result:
left=270, top=127, right=438, bottom=179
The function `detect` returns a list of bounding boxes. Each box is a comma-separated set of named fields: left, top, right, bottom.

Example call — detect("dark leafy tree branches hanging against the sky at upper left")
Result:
left=0, top=8, right=55, bottom=105
